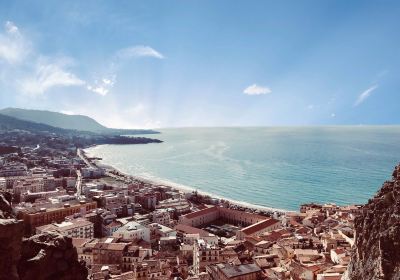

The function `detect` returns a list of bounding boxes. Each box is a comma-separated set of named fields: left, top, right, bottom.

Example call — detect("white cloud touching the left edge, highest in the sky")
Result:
left=0, top=21, right=30, bottom=64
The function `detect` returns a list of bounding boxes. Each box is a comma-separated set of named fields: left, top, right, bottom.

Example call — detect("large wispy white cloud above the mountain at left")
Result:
left=19, top=61, right=85, bottom=96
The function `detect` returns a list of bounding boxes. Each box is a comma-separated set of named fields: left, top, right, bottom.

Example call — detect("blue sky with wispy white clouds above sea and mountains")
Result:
left=0, top=0, right=400, bottom=128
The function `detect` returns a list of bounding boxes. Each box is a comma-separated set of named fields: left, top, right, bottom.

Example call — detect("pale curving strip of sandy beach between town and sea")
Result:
left=81, top=145, right=297, bottom=215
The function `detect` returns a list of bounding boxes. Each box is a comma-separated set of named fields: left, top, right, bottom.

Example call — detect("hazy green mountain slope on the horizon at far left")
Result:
left=0, top=108, right=157, bottom=135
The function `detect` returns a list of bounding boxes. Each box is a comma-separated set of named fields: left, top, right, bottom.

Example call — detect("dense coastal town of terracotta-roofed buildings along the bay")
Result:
left=0, top=145, right=361, bottom=280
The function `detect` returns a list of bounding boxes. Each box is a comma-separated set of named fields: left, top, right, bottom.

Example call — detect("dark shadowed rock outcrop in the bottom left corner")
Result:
left=0, top=193, right=88, bottom=280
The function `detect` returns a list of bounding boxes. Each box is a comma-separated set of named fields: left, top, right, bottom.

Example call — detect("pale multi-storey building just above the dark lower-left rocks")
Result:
left=36, top=219, right=94, bottom=238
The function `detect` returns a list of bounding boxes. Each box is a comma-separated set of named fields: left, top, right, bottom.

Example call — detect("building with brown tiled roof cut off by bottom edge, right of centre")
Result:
left=207, top=263, right=262, bottom=280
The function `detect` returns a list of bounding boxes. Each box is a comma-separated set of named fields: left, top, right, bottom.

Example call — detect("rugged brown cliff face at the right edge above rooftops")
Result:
left=344, top=165, right=400, bottom=280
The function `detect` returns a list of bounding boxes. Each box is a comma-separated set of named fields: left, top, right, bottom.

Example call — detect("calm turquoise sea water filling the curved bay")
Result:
left=88, top=126, right=400, bottom=210
